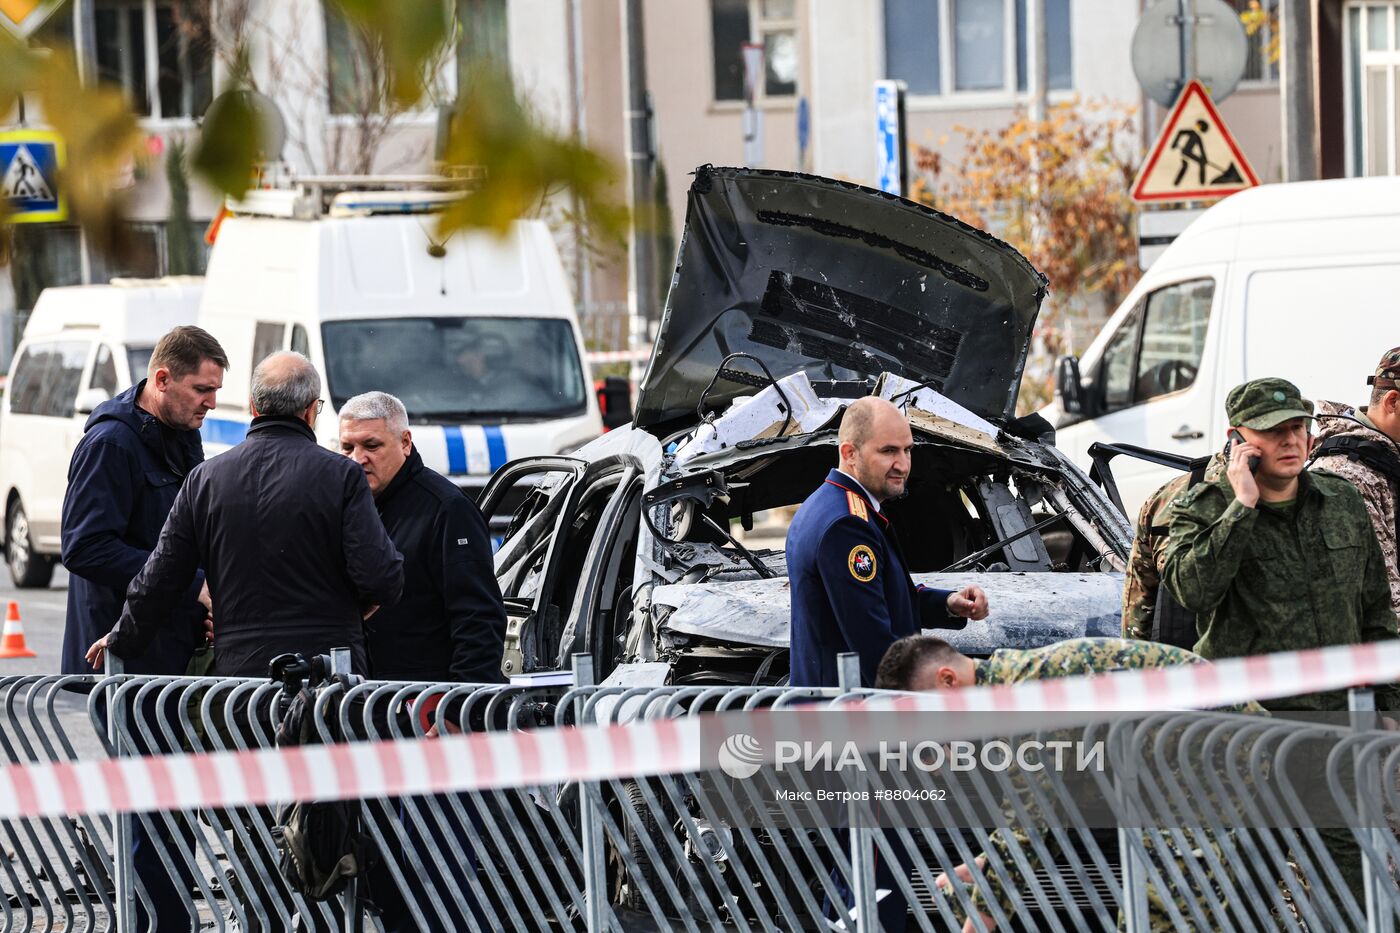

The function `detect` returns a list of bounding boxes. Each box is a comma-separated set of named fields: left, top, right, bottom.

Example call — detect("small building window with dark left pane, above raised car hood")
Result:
left=710, top=0, right=801, bottom=101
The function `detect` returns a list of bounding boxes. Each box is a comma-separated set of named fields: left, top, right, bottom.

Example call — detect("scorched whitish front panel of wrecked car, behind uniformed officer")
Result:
left=651, top=573, right=1123, bottom=654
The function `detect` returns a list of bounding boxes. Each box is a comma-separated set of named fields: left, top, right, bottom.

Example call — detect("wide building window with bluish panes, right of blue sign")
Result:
left=885, top=0, right=1074, bottom=95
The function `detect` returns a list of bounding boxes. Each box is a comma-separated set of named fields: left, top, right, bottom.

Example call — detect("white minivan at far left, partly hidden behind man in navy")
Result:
left=0, top=277, right=203, bottom=587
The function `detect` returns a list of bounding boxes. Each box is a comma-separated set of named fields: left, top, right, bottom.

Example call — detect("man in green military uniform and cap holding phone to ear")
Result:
left=1162, top=378, right=1400, bottom=710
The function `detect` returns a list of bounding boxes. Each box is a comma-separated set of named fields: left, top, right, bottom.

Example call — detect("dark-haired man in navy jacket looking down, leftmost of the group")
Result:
left=60, top=326, right=228, bottom=674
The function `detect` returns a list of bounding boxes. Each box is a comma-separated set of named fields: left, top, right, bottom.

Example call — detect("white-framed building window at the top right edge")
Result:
left=1347, top=3, right=1400, bottom=175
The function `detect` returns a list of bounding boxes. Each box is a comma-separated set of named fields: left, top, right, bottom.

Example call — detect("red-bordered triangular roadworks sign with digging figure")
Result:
left=1133, top=81, right=1259, bottom=202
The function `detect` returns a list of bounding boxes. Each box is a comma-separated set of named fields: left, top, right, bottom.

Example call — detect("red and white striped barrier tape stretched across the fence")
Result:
left=0, top=642, right=1400, bottom=820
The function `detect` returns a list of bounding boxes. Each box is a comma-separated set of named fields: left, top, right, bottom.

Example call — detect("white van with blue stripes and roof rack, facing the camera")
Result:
left=199, top=178, right=602, bottom=496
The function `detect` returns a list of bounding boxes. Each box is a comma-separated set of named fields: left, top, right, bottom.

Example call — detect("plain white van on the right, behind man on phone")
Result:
left=1043, top=177, right=1400, bottom=518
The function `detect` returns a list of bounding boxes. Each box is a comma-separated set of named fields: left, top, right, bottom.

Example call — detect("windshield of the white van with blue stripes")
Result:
left=321, top=317, right=587, bottom=423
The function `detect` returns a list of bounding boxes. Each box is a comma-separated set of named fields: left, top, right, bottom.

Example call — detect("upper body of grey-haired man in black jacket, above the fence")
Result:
left=340, top=392, right=505, bottom=684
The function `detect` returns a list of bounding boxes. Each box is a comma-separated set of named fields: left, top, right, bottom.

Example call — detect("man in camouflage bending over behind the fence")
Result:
left=875, top=635, right=1267, bottom=933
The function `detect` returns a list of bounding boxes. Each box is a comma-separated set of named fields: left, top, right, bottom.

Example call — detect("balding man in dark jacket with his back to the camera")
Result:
left=88, top=353, right=403, bottom=677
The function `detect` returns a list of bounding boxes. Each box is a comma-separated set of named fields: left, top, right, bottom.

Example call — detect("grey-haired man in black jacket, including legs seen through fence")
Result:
left=340, top=392, right=505, bottom=933
